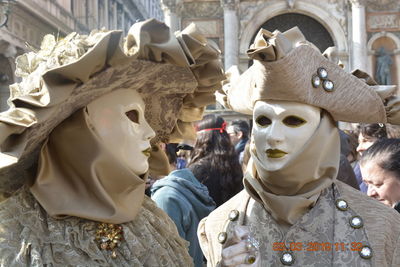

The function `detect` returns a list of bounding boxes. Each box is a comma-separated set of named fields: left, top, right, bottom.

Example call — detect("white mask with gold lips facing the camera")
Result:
left=253, top=100, right=321, bottom=171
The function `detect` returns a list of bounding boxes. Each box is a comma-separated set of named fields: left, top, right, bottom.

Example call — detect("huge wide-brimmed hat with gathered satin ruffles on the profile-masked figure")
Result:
left=0, top=20, right=224, bottom=197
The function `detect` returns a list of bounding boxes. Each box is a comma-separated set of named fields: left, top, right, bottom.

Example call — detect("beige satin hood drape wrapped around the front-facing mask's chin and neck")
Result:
left=244, top=113, right=340, bottom=225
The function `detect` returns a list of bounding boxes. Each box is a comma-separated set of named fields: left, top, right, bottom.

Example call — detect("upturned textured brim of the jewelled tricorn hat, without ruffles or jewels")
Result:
left=225, top=45, right=386, bottom=123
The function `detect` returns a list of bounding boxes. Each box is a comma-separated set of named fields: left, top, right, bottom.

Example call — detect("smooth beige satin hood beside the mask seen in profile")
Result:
left=30, top=108, right=145, bottom=223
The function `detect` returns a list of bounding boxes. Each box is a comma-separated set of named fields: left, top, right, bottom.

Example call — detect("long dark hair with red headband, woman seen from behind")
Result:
left=188, top=114, right=243, bottom=207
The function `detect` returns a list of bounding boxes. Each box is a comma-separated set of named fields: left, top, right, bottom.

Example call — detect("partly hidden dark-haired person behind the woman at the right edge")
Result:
left=353, top=123, right=387, bottom=193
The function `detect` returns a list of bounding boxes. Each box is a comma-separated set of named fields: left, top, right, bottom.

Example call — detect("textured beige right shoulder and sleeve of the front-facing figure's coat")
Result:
left=336, top=181, right=400, bottom=266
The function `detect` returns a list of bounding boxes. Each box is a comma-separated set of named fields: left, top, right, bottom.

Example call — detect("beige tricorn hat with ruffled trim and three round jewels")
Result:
left=216, top=27, right=400, bottom=124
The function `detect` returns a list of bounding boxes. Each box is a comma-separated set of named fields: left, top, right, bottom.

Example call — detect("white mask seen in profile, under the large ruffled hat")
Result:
left=87, top=89, right=155, bottom=175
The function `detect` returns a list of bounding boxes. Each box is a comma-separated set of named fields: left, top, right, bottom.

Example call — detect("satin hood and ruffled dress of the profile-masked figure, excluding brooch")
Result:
left=0, top=109, right=191, bottom=266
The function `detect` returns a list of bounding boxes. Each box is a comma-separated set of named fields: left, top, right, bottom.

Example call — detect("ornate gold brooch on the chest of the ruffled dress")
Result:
left=96, top=223, right=124, bottom=259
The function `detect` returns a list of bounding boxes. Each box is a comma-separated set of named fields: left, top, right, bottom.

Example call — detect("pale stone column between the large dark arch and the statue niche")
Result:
left=350, top=0, right=368, bottom=71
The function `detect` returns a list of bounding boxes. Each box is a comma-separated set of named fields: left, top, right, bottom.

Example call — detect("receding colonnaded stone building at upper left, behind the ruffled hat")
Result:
left=0, top=0, right=164, bottom=110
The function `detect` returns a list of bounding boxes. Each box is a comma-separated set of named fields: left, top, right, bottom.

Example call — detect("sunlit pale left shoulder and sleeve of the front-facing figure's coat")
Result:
left=197, top=190, right=249, bottom=266
